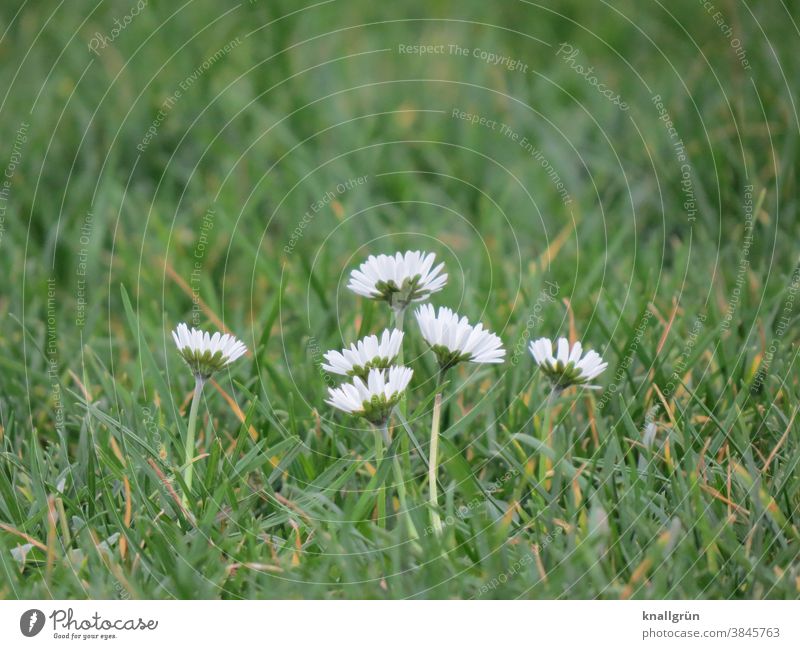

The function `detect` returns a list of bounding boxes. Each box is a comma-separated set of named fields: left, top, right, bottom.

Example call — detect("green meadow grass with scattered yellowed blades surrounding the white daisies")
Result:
left=0, top=0, right=800, bottom=599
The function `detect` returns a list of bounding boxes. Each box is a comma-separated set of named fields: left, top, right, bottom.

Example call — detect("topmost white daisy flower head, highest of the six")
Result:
left=347, top=250, right=447, bottom=310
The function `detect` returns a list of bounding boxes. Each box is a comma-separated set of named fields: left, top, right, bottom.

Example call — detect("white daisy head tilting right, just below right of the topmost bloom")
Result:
left=415, top=304, right=506, bottom=370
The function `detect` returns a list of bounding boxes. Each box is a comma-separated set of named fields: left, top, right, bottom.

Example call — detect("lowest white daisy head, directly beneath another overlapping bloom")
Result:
left=325, top=365, right=414, bottom=425
